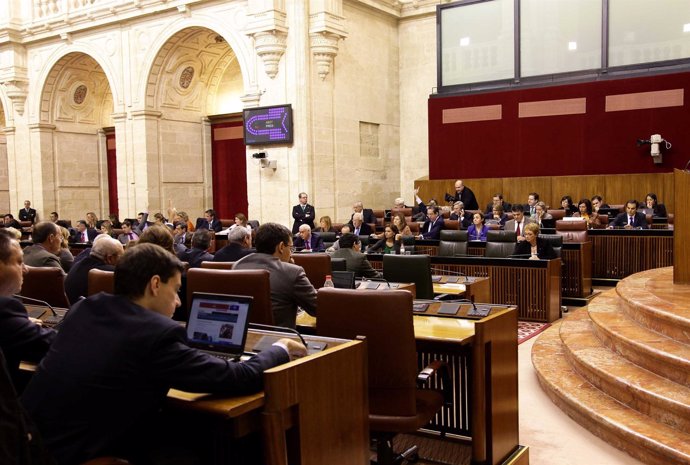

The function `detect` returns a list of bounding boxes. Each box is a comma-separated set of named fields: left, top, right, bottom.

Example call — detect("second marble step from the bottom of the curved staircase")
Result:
left=560, top=308, right=690, bottom=431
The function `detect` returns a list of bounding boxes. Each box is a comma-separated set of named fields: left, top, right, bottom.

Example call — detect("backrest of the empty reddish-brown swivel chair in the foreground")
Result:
left=316, top=288, right=417, bottom=416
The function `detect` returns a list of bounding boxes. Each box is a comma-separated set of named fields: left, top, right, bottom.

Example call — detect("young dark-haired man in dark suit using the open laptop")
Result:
left=21, top=244, right=306, bottom=464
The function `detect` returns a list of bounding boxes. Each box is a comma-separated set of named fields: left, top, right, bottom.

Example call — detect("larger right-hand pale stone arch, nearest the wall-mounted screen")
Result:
left=137, top=15, right=257, bottom=110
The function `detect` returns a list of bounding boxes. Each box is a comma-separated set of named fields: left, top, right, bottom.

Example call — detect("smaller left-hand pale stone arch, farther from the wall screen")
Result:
left=29, top=44, right=123, bottom=123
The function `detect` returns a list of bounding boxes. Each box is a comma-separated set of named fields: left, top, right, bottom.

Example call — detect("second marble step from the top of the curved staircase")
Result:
left=587, top=289, right=690, bottom=387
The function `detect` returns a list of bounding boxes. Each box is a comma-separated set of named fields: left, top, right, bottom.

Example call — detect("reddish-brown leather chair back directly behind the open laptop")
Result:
left=187, top=268, right=273, bottom=325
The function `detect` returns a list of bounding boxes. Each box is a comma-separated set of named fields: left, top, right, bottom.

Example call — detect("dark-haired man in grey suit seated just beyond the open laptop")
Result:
left=233, top=223, right=316, bottom=328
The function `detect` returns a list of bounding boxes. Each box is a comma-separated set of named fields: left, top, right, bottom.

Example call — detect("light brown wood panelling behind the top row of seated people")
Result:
left=414, top=173, right=675, bottom=213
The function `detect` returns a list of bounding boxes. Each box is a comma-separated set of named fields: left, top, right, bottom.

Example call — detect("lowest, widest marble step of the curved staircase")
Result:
left=536, top=323, right=690, bottom=465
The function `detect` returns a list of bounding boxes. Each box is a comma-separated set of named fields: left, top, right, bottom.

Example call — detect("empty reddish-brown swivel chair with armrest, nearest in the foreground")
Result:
left=316, top=288, right=450, bottom=465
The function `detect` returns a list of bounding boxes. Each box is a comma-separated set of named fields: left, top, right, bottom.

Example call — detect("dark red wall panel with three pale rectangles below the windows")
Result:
left=429, top=73, right=690, bottom=179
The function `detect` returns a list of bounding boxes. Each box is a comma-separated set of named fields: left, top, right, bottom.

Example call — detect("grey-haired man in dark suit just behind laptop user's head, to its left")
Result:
left=65, top=234, right=124, bottom=305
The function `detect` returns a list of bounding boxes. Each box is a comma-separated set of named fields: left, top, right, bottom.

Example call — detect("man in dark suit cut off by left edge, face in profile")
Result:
left=0, top=227, right=55, bottom=389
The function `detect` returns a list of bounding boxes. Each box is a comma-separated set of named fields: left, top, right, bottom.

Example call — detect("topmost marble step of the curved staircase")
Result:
left=616, top=267, right=690, bottom=344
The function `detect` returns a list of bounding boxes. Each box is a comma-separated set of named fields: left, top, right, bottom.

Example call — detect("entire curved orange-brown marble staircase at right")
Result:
left=532, top=268, right=690, bottom=465
